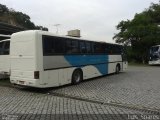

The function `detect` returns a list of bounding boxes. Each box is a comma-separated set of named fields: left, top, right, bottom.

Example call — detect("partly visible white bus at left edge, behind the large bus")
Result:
left=0, top=39, right=10, bottom=78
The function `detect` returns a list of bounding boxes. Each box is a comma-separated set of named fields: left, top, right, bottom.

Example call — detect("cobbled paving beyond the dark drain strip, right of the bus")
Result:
left=51, top=66, right=160, bottom=109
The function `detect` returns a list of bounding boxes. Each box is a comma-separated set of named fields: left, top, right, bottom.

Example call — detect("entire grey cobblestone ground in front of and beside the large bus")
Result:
left=0, top=66, right=160, bottom=120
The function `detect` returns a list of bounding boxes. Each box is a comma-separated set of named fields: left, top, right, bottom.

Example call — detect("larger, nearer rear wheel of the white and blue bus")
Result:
left=72, top=69, right=83, bottom=85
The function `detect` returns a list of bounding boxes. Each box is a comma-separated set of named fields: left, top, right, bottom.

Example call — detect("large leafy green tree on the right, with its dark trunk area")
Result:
left=113, top=2, right=160, bottom=63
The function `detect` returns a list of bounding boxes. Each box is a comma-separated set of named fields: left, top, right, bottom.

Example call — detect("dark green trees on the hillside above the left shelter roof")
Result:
left=0, top=4, right=48, bottom=31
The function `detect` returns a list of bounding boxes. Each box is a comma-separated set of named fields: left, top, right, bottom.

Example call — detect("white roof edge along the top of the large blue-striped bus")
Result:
left=12, top=30, right=120, bottom=45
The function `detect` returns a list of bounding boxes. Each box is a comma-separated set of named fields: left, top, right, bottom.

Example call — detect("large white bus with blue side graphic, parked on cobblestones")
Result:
left=10, top=30, right=127, bottom=88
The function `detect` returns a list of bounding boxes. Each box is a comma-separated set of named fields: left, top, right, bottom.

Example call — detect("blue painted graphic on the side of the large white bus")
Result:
left=64, top=55, right=108, bottom=75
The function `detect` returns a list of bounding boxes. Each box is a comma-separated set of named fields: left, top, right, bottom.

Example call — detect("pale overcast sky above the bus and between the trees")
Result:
left=0, top=0, right=159, bottom=43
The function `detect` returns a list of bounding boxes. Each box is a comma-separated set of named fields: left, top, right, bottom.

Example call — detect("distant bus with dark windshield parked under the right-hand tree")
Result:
left=149, top=45, right=160, bottom=65
